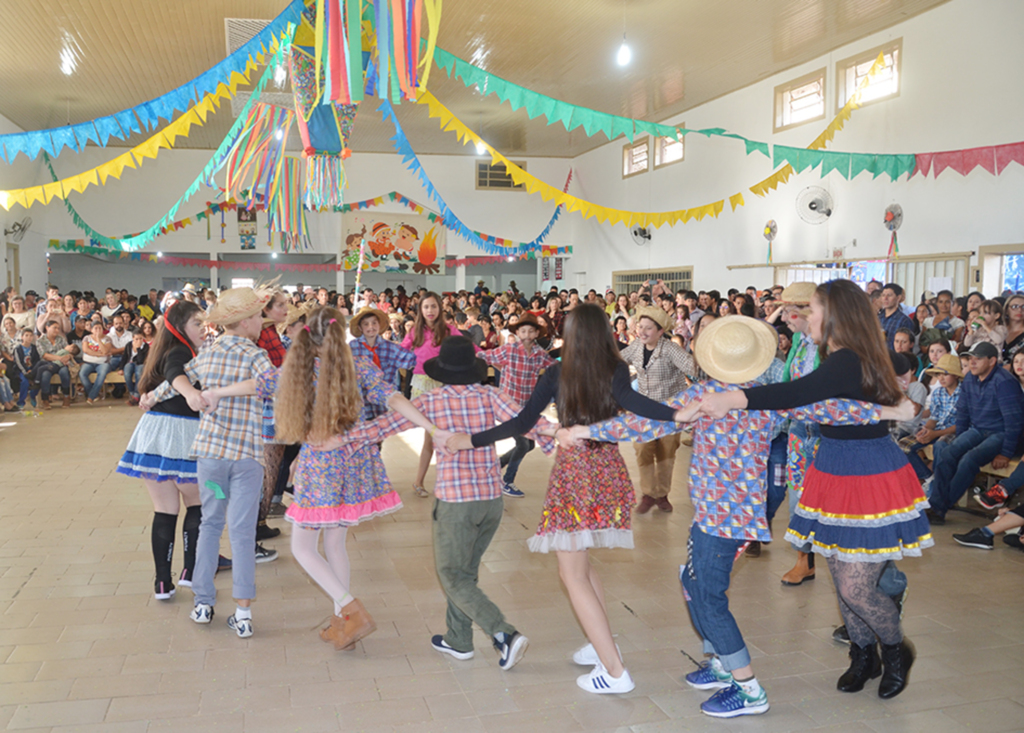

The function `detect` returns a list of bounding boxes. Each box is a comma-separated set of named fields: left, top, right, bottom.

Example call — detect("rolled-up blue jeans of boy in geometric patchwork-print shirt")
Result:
left=679, top=524, right=751, bottom=672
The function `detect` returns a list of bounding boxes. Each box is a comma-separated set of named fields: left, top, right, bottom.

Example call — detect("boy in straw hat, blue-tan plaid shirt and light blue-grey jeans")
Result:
left=143, top=288, right=273, bottom=639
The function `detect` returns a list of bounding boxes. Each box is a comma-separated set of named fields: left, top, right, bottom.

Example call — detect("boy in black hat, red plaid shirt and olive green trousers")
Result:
left=324, top=336, right=554, bottom=670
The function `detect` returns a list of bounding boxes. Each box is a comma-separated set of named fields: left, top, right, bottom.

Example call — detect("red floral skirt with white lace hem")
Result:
left=527, top=440, right=635, bottom=553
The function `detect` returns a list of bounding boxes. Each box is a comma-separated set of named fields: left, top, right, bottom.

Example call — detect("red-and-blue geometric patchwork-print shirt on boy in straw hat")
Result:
left=590, top=379, right=882, bottom=542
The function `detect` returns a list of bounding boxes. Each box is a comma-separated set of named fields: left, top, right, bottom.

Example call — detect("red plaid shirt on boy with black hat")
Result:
left=343, top=384, right=554, bottom=502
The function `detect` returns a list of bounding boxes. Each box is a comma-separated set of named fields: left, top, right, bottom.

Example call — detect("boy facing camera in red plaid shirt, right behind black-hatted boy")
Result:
left=480, top=313, right=555, bottom=499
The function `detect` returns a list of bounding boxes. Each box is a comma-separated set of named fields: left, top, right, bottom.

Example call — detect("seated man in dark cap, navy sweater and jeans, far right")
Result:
left=928, top=341, right=1024, bottom=525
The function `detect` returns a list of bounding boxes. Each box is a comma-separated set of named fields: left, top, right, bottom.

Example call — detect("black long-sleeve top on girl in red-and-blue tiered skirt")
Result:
left=743, top=349, right=889, bottom=440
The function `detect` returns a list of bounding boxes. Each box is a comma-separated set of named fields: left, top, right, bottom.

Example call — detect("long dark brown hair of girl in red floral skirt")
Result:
left=558, top=303, right=623, bottom=426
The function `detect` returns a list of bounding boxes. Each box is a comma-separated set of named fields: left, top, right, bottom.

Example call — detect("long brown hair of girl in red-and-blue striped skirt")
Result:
left=814, top=279, right=903, bottom=405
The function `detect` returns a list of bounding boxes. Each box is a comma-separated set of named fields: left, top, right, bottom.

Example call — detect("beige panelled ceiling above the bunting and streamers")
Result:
left=0, top=0, right=946, bottom=157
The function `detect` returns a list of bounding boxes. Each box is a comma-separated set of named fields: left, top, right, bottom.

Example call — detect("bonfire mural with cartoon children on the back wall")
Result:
left=342, top=211, right=445, bottom=274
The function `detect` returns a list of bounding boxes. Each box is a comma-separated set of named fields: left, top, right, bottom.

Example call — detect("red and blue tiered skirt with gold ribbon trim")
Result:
left=785, top=436, right=935, bottom=562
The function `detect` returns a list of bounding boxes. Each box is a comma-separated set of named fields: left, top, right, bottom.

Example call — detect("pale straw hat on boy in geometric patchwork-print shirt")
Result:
left=694, top=315, right=778, bottom=384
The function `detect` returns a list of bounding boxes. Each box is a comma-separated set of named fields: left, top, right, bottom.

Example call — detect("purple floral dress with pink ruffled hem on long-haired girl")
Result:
left=256, top=356, right=401, bottom=529
